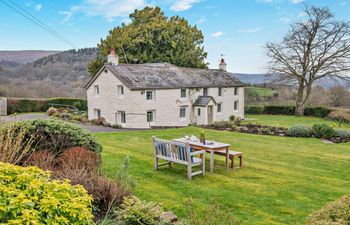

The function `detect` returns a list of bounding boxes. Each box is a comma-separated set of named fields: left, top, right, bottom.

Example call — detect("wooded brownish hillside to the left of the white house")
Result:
left=0, top=48, right=98, bottom=98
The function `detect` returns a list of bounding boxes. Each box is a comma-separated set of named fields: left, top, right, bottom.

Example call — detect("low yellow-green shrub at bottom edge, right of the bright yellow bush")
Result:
left=116, top=196, right=167, bottom=225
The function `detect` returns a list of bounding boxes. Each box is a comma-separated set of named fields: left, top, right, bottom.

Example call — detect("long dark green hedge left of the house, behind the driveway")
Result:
left=7, top=98, right=87, bottom=114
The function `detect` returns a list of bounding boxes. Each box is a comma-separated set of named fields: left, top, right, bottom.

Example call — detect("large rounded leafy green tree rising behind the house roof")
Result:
left=91, top=7, right=207, bottom=76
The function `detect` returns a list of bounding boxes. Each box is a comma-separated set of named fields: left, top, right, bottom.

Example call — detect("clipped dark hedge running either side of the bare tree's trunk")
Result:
left=245, top=106, right=332, bottom=118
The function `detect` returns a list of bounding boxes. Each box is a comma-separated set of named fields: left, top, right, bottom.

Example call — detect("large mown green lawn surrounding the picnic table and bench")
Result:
left=94, top=127, right=350, bottom=224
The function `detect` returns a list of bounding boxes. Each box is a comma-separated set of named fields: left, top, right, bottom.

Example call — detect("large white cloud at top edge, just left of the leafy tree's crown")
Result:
left=60, top=0, right=146, bottom=21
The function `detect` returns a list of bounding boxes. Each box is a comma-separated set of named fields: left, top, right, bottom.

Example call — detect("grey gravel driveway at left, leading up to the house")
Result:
left=0, top=113, right=134, bottom=132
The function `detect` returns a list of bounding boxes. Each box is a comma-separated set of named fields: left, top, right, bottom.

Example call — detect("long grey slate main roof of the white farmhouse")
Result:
left=85, top=63, right=244, bottom=90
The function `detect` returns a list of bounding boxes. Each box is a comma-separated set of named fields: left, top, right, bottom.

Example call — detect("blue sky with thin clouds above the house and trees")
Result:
left=0, top=0, right=350, bottom=73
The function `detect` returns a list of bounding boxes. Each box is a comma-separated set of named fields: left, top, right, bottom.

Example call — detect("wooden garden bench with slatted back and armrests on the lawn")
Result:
left=153, top=137, right=205, bottom=180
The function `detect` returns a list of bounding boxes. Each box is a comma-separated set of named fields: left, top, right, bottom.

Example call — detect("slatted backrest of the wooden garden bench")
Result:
left=153, top=137, right=191, bottom=162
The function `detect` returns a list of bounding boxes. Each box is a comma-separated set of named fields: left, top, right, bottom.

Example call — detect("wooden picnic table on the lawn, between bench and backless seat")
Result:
left=174, top=138, right=231, bottom=174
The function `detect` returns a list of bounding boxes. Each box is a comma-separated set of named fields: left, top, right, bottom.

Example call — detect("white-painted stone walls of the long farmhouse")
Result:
left=87, top=68, right=244, bottom=128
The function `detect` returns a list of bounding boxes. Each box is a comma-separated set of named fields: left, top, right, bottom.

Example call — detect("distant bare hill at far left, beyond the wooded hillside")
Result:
left=0, top=50, right=59, bottom=64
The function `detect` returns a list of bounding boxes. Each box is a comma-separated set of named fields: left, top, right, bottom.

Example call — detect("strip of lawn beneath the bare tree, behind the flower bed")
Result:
left=243, top=115, right=350, bottom=129
